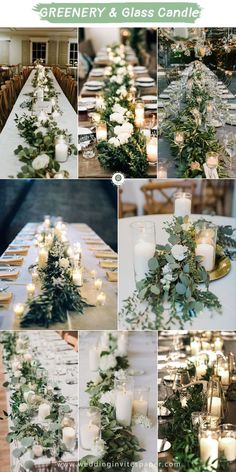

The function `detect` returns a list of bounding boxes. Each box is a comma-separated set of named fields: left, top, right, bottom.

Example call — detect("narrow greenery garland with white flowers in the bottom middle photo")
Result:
left=79, top=334, right=143, bottom=472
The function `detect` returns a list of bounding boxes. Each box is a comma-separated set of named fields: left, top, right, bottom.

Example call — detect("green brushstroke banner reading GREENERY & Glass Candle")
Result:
left=33, top=2, right=201, bottom=24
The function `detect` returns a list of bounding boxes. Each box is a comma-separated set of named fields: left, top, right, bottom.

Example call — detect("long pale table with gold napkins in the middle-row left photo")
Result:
left=0, top=223, right=117, bottom=330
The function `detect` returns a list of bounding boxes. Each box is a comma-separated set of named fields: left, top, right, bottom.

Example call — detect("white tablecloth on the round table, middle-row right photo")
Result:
left=119, top=215, right=236, bottom=330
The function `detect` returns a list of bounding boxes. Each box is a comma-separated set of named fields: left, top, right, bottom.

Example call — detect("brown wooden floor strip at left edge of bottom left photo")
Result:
left=0, top=346, right=10, bottom=472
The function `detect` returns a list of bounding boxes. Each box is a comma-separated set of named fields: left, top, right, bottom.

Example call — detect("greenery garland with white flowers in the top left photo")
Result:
left=14, top=64, right=77, bottom=178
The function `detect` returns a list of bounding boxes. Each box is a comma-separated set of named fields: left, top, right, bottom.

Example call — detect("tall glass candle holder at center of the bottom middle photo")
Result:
left=115, top=377, right=134, bottom=426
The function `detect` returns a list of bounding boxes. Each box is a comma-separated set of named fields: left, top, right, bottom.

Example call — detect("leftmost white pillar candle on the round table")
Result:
left=134, top=240, right=155, bottom=280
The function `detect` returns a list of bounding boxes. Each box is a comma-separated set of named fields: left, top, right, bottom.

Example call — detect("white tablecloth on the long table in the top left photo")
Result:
left=0, top=70, right=78, bottom=179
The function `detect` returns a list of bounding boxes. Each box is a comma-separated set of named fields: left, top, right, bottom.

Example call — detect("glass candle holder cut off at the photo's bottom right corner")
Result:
left=219, top=424, right=236, bottom=462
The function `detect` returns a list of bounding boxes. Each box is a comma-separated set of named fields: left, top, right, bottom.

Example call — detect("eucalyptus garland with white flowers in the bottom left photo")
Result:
left=0, top=331, right=75, bottom=470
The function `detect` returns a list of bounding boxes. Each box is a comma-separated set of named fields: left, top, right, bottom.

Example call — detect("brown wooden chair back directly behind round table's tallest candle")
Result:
left=141, top=180, right=201, bottom=215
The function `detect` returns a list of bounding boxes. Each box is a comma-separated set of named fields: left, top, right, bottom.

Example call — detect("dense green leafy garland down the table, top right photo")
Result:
left=163, top=63, right=228, bottom=178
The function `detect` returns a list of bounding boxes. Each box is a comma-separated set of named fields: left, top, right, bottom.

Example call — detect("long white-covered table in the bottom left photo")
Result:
left=6, top=331, right=78, bottom=472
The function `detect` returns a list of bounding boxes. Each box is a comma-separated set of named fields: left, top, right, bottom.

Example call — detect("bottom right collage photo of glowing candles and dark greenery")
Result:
left=158, top=331, right=236, bottom=472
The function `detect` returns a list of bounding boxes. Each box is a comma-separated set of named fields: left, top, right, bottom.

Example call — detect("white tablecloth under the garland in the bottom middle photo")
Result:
left=79, top=332, right=157, bottom=462
